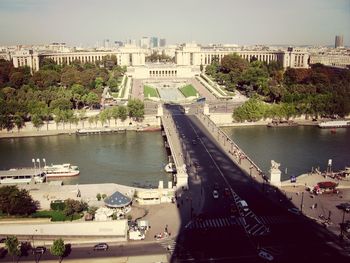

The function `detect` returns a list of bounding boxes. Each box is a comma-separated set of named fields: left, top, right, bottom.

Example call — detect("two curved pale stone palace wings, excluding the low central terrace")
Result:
left=12, top=44, right=309, bottom=75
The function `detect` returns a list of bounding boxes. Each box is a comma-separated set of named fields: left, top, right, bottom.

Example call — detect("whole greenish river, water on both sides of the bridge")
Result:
left=0, top=126, right=350, bottom=186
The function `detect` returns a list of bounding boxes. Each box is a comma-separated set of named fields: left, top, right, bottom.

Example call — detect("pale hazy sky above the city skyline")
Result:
left=0, top=0, right=350, bottom=46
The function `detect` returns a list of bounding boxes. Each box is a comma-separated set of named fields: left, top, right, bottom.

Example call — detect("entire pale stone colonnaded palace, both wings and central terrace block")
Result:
left=11, top=43, right=309, bottom=78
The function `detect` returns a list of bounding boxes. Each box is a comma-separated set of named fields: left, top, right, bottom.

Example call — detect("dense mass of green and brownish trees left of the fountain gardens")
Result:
left=0, top=56, right=138, bottom=130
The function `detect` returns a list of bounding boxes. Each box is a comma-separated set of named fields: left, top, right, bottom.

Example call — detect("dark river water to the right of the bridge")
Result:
left=223, top=126, right=350, bottom=180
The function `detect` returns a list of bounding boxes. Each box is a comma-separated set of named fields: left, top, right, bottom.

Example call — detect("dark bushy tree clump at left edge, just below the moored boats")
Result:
left=0, top=186, right=38, bottom=215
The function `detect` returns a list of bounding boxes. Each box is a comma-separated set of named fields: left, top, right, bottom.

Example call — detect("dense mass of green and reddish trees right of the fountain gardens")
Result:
left=205, top=54, right=350, bottom=120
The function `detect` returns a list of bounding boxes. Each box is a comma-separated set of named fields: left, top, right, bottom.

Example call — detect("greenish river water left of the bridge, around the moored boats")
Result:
left=0, top=131, right=171, bottom=187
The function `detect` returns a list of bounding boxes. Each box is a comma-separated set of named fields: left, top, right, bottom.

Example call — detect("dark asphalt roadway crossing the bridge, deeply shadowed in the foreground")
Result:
left=167, top=105, right=345, bottom=262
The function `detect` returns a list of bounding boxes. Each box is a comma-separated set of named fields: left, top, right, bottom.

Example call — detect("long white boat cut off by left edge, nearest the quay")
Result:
left=0, top=169, right=46, bottom=184
